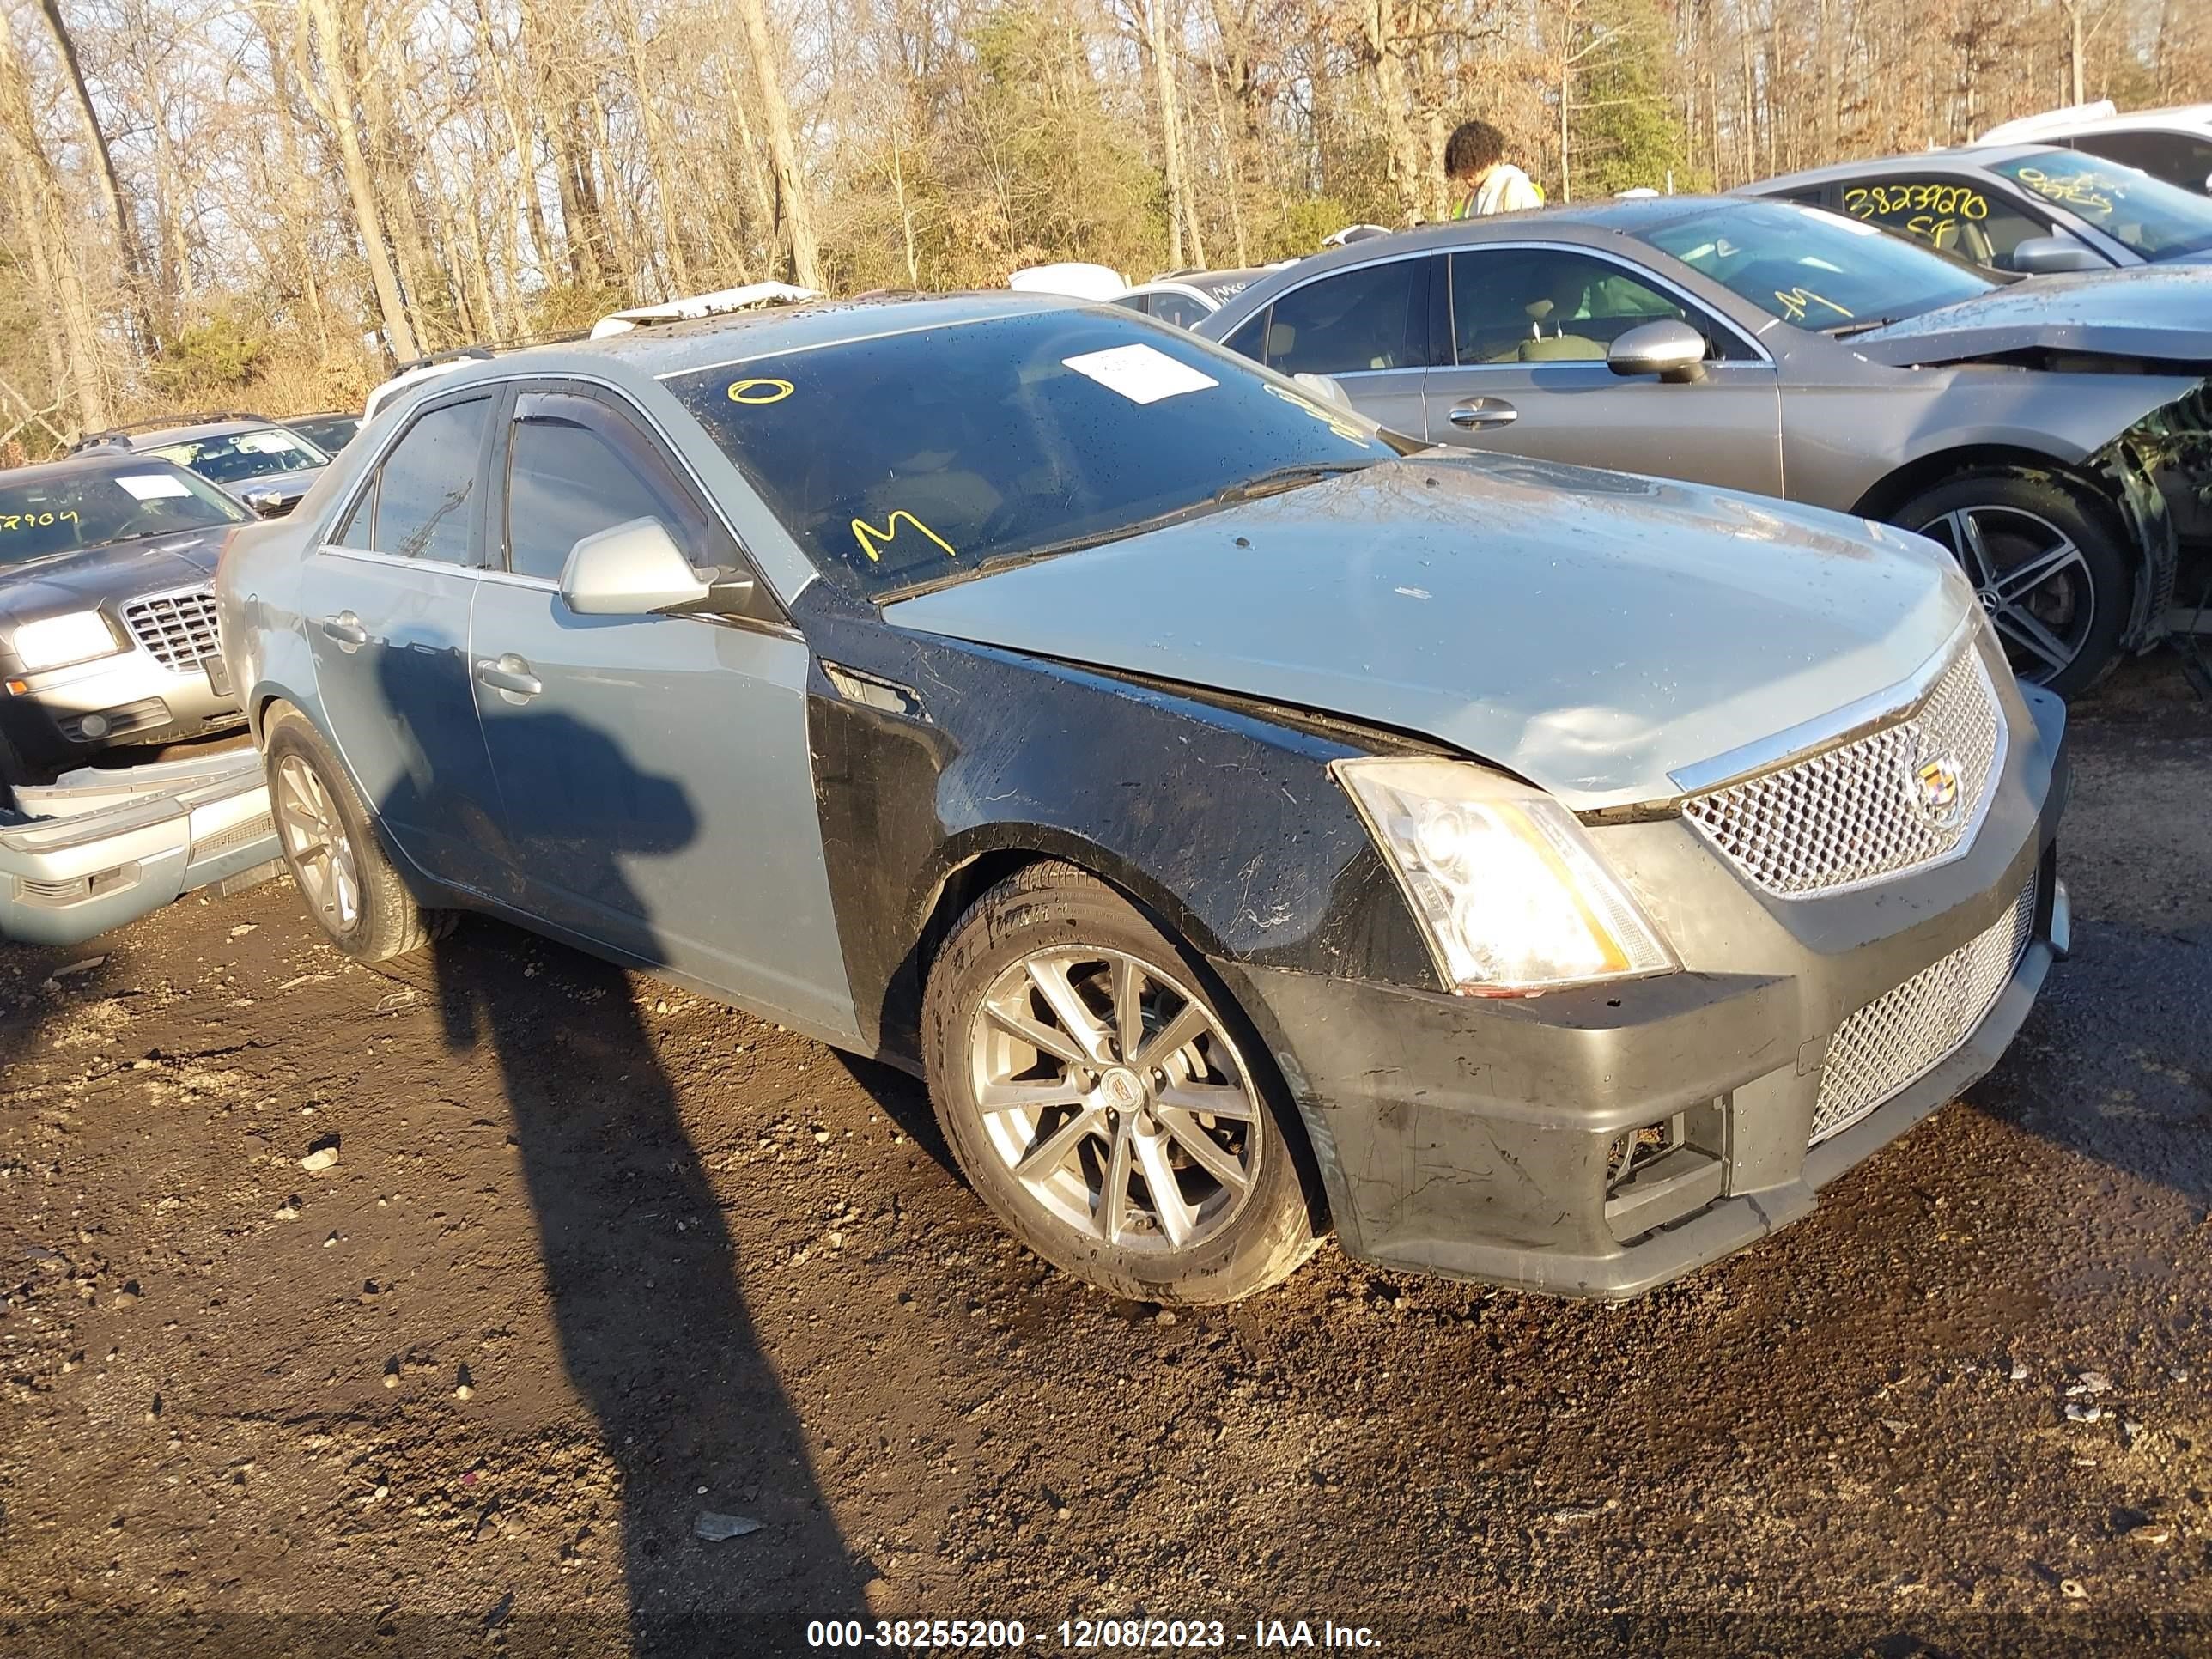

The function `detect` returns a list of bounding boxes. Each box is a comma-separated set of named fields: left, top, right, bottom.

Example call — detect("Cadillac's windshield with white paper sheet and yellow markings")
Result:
left=668, top=310, right=1394, bottom=599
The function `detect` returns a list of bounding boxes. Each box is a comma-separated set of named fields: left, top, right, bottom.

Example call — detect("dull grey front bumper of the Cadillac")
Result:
left=1214, top=688, right=2069, bottom=1298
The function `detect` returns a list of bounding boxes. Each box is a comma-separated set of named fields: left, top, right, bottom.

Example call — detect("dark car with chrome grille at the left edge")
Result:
left=0, top=456, right=252, bottom=805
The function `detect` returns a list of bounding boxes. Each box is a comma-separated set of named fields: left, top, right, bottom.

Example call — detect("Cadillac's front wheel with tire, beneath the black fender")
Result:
left=922, top=863, right=1318, bottom=1305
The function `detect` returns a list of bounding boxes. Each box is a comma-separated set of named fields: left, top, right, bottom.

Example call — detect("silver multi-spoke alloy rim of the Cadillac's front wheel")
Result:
left=969, top=947, right=1265, bottom=1249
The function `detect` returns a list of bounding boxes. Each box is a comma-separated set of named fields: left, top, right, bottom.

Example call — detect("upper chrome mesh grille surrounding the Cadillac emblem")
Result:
left=1681, top=644, right=2004, bottom=898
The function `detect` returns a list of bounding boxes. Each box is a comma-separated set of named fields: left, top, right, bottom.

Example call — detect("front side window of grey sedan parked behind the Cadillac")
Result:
left=1451, top=248, right=1741, bottom=365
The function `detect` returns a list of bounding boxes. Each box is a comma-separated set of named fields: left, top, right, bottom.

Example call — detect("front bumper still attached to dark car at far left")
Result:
left=0, top=644, right=246, bottom=769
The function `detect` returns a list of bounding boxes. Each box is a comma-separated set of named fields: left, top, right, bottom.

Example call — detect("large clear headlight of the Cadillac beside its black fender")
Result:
left=1329, top=759, right=1674, bottom=995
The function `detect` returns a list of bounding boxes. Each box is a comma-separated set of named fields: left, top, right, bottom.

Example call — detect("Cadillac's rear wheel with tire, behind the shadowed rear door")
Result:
left=261, top=708, right=447, bottom=963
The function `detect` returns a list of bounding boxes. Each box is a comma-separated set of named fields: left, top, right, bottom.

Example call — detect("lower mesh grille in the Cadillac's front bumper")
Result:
left=1812, top=878, right=2035, bottom=1146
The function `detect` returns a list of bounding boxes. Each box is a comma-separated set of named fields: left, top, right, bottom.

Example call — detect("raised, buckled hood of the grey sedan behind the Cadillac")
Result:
left=1847, top=264, right=2212, bottom=369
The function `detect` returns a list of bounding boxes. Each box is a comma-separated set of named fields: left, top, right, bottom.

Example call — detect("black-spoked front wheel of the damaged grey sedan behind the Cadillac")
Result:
left=1896, top=471, right=2135, bottom=696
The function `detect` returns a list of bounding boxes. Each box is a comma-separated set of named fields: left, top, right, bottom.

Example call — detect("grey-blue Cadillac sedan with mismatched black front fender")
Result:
left=216, top=295, right=2066, bottom=1303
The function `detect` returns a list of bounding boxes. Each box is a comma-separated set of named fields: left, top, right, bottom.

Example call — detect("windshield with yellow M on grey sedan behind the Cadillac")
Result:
left=1637, top=201, right=1993, bottom=330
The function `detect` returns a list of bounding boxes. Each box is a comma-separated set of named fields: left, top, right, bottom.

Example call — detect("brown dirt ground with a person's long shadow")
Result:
left=0, top=659, right=2212, bottom=1656
